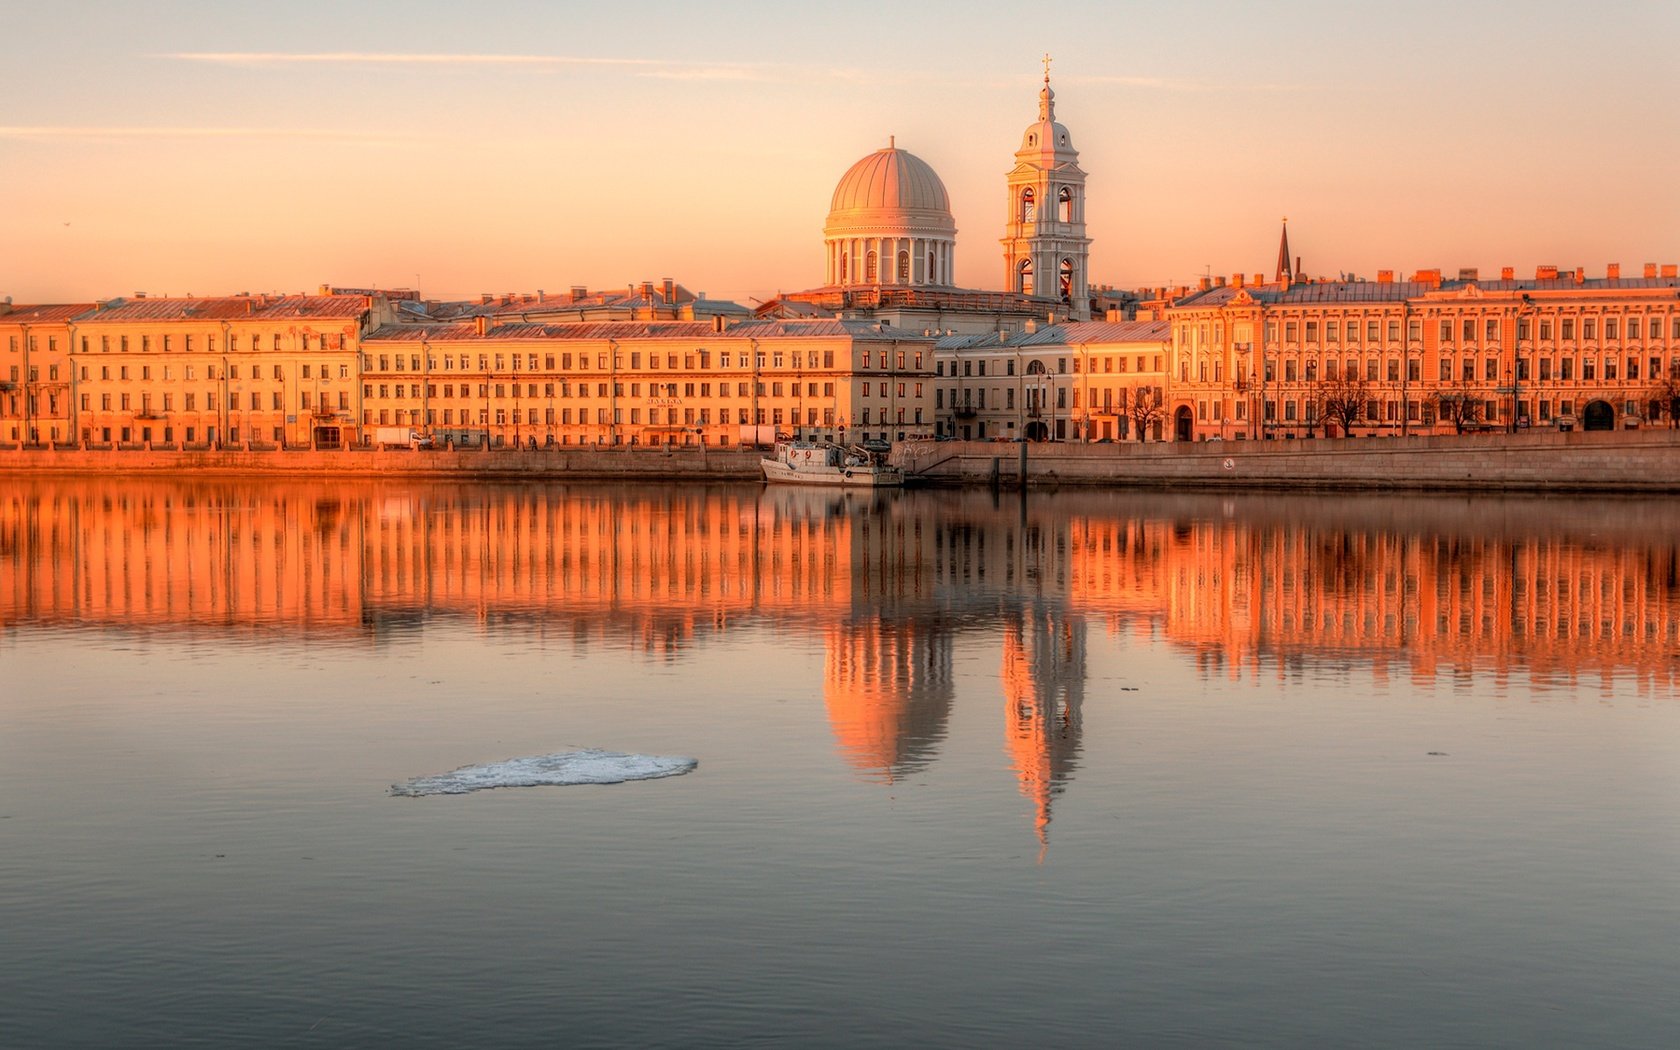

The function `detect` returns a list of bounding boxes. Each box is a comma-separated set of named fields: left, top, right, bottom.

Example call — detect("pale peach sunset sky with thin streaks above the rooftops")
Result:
left=0, top=0, right=1680, bottom=302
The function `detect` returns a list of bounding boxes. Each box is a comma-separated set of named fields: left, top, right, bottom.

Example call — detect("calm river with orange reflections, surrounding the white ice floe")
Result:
left=0, top=479, right=1680, bottom=1047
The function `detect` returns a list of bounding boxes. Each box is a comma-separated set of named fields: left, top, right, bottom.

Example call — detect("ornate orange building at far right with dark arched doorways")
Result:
left=1166, top=264, right=1680, bottom=440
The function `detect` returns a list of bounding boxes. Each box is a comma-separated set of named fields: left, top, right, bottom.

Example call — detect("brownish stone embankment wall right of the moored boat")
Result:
left=892, top=430, right=1680, bottom=492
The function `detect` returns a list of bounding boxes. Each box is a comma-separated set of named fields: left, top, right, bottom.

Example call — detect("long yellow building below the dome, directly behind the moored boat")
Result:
left=358, top=318, right=934, bottom=447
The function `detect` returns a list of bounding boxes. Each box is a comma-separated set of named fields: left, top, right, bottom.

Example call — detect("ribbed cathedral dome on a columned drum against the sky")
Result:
left=823, top=144, right=956, bottom=286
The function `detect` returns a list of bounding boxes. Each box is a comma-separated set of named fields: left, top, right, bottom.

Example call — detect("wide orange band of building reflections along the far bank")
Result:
left=0, top=477, right=1680, bottom=682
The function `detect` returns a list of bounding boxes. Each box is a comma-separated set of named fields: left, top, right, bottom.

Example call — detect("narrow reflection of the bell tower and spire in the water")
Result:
left=1000, top=601, right=1085, bottom=846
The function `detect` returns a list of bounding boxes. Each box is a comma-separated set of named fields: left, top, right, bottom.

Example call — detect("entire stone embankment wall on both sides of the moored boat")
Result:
left=0, top=430, right=1680, bottom=492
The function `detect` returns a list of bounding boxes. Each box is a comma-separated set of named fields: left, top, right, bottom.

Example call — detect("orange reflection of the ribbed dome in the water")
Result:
left=823, top=622, right=953, bottom=781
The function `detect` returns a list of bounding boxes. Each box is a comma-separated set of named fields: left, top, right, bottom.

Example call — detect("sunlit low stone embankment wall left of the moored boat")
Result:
left=0, top=447, right=763, bottom=480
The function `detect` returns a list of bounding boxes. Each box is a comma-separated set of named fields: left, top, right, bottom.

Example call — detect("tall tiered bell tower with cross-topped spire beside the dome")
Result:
left=1001, top=55, right=1090, bottom=321
